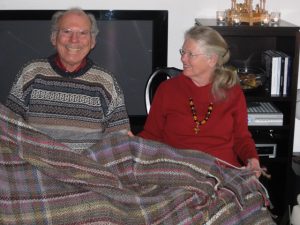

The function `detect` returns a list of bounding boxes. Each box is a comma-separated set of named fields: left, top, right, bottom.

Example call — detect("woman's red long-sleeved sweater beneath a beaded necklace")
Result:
left=139, top=74, right=258, bottom=166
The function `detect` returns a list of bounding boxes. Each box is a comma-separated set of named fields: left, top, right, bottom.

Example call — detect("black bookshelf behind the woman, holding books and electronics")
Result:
left=195, top=18, right=299, bottom=224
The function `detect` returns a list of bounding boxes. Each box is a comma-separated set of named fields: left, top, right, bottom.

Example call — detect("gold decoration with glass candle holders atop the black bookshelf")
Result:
left=226, top=0, right=269, bottom=25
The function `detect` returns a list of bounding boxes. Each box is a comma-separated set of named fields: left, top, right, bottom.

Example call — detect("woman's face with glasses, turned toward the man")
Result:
left=181, top=38, right=216, bottom=84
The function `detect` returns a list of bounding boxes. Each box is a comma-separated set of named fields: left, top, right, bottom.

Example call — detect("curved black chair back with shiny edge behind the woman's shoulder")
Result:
left=145, top=67, right=182, bottom=113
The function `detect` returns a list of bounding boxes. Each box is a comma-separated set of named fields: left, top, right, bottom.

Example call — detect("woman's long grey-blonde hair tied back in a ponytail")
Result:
left=184, top=25, right=239, bottom=100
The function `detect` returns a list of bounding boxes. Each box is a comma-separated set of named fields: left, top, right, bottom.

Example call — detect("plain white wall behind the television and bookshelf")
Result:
left=0, top=0, right=300, bottom=152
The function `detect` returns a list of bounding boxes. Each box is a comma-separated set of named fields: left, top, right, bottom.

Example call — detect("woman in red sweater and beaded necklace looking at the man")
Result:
left=139, top=26, right=260, bottom=176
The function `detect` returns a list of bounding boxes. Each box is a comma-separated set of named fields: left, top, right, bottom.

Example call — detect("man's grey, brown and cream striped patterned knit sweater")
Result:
left=6, top=56, right=130, bottom=151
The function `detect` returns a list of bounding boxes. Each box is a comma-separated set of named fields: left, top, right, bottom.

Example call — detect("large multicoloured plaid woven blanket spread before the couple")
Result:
left=0, top=105, right=275, bottom=225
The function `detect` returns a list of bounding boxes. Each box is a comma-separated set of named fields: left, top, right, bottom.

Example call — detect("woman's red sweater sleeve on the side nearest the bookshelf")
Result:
left=233, top=88, right=258, bottom=165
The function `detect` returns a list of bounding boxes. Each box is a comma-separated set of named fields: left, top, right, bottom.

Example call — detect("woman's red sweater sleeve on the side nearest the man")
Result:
left=138, top=82, right=166, bottom=142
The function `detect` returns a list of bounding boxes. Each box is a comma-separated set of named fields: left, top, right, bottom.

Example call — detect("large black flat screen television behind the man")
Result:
left=0, top=10, right=168, bottom=117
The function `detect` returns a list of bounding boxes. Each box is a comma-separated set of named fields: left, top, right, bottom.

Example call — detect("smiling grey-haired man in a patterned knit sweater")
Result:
left=6, top=9, right=129, bottom=151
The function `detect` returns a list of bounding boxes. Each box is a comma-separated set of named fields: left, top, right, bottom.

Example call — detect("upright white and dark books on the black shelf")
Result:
left=262, top=50, right=292, bottom=96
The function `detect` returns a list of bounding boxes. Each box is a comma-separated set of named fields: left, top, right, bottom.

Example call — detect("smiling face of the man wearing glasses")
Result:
left=52, top=12, right=95, bottom=72
